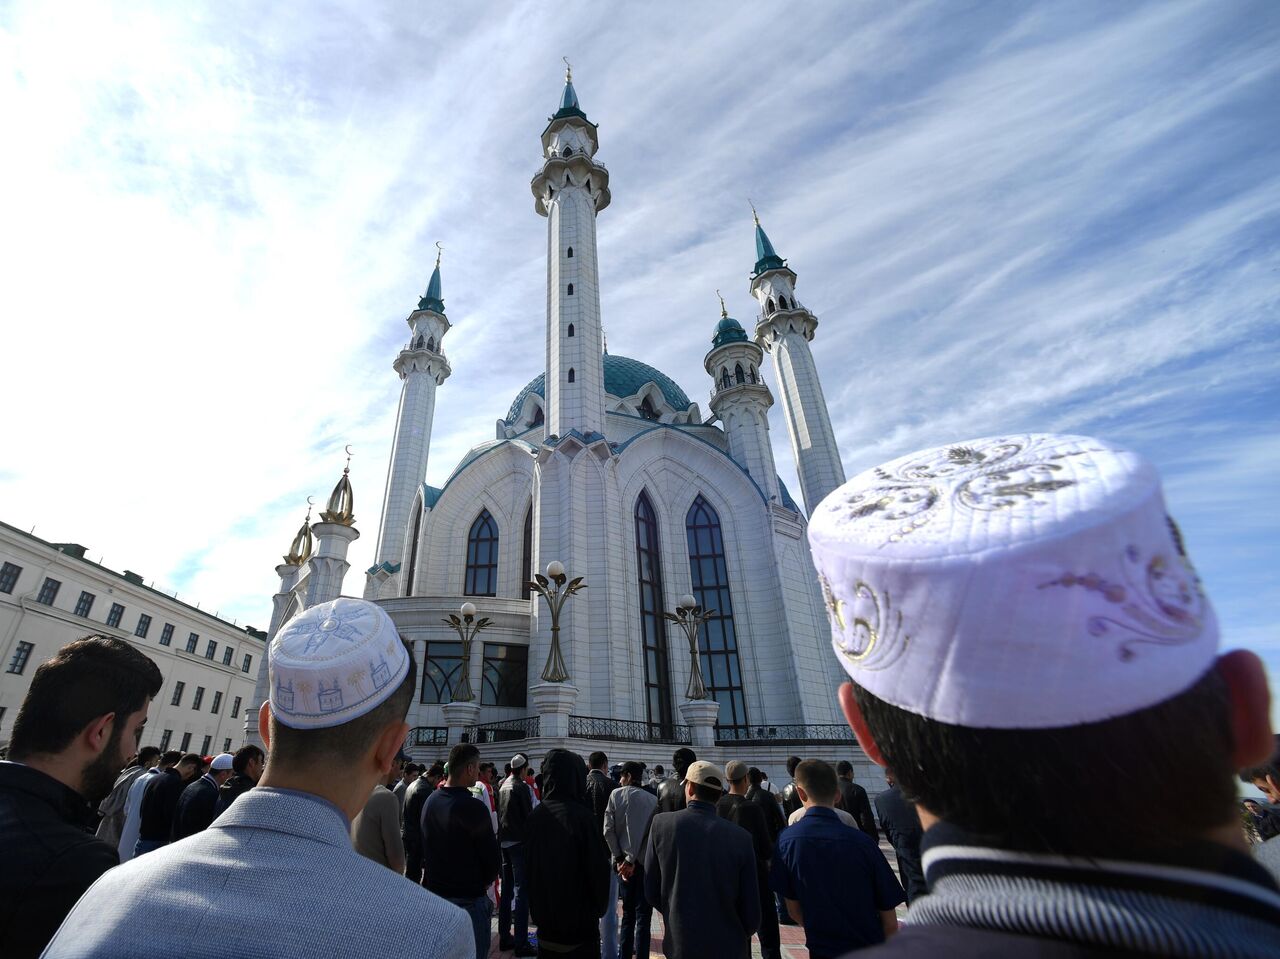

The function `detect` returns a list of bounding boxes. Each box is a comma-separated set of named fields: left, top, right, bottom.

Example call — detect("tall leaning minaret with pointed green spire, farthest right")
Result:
left=751, top=207, right=845, bottom=515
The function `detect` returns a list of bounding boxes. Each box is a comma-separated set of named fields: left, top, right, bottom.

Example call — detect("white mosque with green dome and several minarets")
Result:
left=247, top=69, right=867, bottom=768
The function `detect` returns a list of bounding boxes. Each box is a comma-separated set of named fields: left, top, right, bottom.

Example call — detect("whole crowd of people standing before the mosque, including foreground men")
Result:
left=0, top=435, right=1280, bottom=959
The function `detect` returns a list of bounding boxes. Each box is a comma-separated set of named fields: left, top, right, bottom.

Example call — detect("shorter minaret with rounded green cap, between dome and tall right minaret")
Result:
left=703, top=291, right=778, bottom=503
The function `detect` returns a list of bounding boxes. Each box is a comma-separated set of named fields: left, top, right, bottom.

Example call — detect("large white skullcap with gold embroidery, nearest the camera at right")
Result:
left=809, top=434, right=1217, bottom=729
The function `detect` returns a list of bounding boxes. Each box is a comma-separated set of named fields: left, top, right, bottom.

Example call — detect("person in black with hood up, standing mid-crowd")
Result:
left=525, top=749, right=612, bottom=959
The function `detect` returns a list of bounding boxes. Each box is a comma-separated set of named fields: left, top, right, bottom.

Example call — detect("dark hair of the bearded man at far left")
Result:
left=9, top=635, right=163, bottom=762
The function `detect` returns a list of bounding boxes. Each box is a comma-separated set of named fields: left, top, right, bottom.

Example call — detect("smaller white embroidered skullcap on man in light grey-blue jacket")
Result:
left=269, top=597, right=410, bottom=729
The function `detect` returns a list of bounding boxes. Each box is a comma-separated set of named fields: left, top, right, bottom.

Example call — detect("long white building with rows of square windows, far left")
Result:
left=0, top=522, right=266, bottom=755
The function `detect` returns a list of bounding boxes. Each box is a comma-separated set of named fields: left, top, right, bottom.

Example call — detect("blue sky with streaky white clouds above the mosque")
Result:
left=0, top=0, right=1280, bottom=711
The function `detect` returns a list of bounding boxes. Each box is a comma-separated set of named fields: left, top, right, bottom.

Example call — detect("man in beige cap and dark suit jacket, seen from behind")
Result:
left=644, top=762, right=760, bottom=959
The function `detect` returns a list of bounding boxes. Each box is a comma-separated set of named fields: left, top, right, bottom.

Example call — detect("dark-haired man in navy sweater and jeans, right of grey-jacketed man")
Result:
left=421, top=743, right=502, bottom=959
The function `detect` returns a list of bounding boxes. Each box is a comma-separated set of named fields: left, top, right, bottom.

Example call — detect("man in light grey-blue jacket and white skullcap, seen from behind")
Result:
left=45, top=598, right=475, bottom=959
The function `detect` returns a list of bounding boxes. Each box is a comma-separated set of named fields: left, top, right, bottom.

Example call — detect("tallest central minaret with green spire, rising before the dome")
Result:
left=532, top=65, right=609, bottom=437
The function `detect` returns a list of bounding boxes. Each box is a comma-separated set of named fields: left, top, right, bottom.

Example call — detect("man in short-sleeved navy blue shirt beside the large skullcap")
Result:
left=769, top=759, right=906, bottom=959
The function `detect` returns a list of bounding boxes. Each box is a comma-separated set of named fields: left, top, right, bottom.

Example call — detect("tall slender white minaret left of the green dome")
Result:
left=365, top=243, right=453, bottom=599
